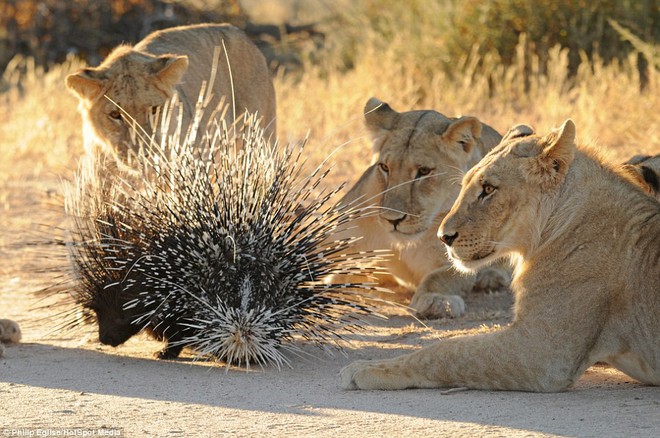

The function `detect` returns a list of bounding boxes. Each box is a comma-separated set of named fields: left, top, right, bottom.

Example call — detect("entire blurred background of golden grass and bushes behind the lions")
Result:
left=0, top=0, right=660, bottom=185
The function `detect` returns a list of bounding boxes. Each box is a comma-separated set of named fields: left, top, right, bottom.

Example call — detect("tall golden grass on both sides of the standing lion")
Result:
left=0, top=21, right=660, bottom=190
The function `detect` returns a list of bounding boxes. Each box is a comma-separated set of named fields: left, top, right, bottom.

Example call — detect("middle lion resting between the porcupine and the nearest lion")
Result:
left=341, top=98, right=508, bottom=318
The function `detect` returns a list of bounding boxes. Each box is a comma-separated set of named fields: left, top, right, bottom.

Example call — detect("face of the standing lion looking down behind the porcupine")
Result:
left=66, top=47, right=188, bottom=157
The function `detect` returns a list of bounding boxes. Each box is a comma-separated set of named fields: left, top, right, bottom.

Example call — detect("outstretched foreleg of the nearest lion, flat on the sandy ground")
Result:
left=341, top=327, right=590, bottom=392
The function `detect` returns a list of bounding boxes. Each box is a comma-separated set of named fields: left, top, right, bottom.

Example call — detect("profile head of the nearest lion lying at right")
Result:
left=438, top=121, right=575, bottom=271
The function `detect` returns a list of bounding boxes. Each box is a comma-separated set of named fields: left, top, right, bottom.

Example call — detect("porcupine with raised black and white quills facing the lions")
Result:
left=67, top=108, right=379, bottom=368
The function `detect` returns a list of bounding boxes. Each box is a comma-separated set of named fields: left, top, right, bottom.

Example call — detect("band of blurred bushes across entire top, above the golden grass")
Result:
left=0, top=0, right=660, bottom=81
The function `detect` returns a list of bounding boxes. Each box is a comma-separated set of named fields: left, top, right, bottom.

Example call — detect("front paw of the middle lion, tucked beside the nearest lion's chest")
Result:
left=410, top=266, right=475, bottom=319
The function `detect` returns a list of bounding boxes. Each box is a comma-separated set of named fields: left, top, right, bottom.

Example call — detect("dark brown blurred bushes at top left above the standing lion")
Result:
left=0, top=0, right=244, bottom=69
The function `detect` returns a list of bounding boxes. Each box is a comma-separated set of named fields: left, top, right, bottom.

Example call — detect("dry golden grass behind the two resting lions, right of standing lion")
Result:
left=276, top=36, right=660, bottom=189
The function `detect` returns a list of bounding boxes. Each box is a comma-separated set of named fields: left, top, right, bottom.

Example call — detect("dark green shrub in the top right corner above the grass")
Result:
left=447, top=0, right=660, bottom=73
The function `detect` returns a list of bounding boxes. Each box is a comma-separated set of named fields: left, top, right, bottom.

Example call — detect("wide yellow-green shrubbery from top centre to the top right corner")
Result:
left=321, top=0, right=660, bottom=81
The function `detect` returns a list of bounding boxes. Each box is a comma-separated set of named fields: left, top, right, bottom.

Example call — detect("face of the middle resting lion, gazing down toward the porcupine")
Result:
left=365, top=99, right=482, bottom=236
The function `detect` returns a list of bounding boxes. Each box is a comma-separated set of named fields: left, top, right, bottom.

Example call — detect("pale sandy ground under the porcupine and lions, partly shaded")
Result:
left=0, top=177, right=660, bottom=437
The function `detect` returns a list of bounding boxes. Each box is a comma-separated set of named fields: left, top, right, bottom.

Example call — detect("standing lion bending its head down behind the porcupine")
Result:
left=66, top=24, right=276, bottom=158
